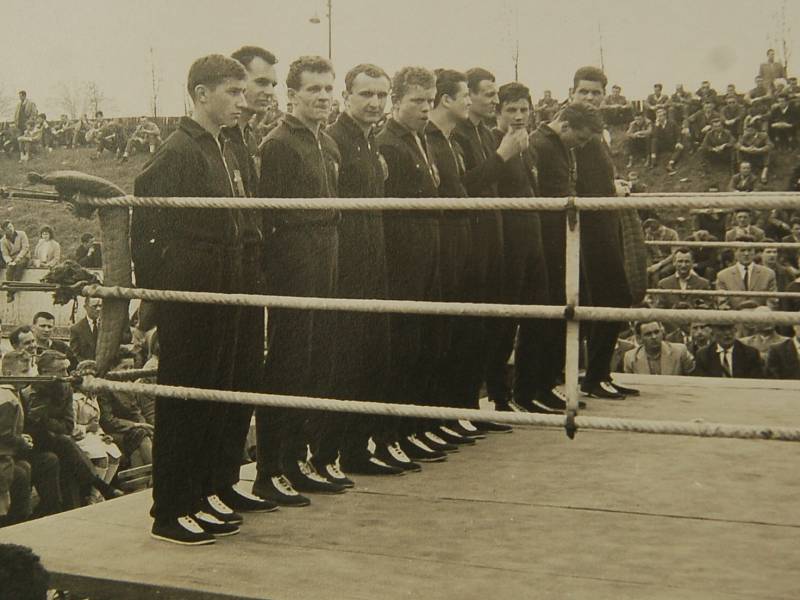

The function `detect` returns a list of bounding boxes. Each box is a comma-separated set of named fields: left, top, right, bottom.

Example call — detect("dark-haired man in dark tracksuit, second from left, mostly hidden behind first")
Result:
left=215, top=46, right=277, bottom=512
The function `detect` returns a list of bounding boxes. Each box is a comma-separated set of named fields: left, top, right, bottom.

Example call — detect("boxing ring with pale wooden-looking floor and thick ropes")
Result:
left=1, top=184, right=800, bottom=600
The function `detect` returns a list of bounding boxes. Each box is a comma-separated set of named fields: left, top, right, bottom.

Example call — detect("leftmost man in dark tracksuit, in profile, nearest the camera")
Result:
left=131, top=55, right=250, bottom=545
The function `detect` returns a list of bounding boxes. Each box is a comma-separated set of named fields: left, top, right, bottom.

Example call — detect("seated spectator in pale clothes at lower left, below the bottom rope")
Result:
left=73, top=360, right=122, bottom=504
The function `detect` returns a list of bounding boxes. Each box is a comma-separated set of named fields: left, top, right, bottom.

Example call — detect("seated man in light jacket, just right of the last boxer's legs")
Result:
left=624, top=321, right=694, bottom=375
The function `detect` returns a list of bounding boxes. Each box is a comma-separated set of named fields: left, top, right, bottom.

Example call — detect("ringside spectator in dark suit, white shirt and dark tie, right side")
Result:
left=694, top=323, right=764, bottom=379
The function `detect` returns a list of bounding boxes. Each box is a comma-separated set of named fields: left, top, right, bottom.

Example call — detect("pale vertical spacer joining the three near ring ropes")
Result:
left=564, top=198, right=581, bottom=439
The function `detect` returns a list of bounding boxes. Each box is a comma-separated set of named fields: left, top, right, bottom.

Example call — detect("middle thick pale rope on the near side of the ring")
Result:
left=81, top=285, right=800, bottom=325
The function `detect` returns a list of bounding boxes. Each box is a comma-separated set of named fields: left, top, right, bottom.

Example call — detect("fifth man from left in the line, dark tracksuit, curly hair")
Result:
left=375, top=67, right=446, bottom=470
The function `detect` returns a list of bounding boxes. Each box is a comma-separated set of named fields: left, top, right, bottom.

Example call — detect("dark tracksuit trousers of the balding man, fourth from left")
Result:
left=312, top=211, right=395, bottom=465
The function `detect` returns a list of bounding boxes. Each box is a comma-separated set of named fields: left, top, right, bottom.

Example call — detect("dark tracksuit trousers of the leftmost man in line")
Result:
left=150, top=242, right=242, bottom=520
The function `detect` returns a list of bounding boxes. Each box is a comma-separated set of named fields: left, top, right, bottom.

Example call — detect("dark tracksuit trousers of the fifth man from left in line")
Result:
left=384, top=213, right=442, bottom=435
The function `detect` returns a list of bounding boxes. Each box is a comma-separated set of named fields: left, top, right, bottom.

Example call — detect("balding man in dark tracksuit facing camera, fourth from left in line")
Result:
left=312, top=64, right=403, bottom=483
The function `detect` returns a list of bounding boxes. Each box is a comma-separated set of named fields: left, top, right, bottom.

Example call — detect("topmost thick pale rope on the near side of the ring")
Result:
left=75, top=192, right=800, bottom=211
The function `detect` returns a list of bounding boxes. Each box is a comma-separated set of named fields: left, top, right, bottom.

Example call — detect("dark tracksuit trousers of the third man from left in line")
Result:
left=256, top=223, right=339, bottom=478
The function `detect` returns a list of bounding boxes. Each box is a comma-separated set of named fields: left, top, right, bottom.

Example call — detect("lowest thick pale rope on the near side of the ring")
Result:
left=81, top=376, right=800, bottom=442
